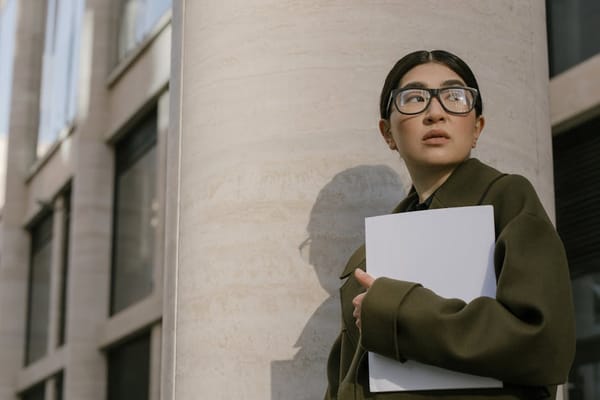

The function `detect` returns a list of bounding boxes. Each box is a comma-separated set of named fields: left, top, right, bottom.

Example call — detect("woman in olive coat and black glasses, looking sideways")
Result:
left=325, top=50, right=575, bottom=400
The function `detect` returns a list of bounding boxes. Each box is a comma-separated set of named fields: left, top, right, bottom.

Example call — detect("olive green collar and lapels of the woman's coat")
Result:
left=340, top=158, right=504, bottom=279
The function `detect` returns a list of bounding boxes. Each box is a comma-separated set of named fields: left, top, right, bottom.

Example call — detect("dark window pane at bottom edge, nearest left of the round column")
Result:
left=108, top=333, right=150, bottom=400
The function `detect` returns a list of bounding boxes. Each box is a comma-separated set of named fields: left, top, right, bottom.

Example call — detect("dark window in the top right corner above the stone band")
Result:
left=546, top=0, right=600, bottom=76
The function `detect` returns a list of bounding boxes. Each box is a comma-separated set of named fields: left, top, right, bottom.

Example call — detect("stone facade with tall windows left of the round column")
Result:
left=0, top=0, right=171, bottom=400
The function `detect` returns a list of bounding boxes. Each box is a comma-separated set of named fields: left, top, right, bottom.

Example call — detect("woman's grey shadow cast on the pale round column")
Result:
left=271, top=165, right=405, bottom=400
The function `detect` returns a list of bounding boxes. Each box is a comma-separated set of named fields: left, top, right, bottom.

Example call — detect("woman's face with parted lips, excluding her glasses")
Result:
left=379, top=62, right=484, bottom=172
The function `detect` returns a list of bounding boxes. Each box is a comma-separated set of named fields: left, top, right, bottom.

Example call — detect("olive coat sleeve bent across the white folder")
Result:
left=361, top=175, right=575, bottom=385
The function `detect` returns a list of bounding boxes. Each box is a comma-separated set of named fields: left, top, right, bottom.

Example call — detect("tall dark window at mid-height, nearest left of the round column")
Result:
left=111, top=110, right=158, bottom=315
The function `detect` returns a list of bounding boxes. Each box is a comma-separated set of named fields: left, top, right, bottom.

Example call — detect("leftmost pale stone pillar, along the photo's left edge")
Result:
left=0, top=1, right=45, bottom=400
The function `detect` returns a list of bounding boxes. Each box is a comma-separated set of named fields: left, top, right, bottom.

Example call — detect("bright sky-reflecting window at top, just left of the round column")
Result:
left=117, top=0, right=172, bottom=60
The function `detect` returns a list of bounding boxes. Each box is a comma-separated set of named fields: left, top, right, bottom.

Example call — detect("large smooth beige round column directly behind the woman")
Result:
left=163, top=0, right=553, bottom=399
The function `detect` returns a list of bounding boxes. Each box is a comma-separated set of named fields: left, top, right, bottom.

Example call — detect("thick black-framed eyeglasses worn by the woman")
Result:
left=387, top=86, right=478, bottom=115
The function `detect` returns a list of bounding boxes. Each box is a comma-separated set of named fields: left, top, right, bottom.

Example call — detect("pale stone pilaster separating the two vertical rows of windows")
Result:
left=63, top=0, right=114, bottom=400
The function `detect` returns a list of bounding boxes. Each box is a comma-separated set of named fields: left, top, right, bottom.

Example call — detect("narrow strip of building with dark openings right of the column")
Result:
left=547, top=0, right=600, bottom=400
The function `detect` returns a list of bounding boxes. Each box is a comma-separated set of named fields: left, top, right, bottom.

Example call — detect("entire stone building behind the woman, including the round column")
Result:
left=0, top=0, right=600, bottom=400
